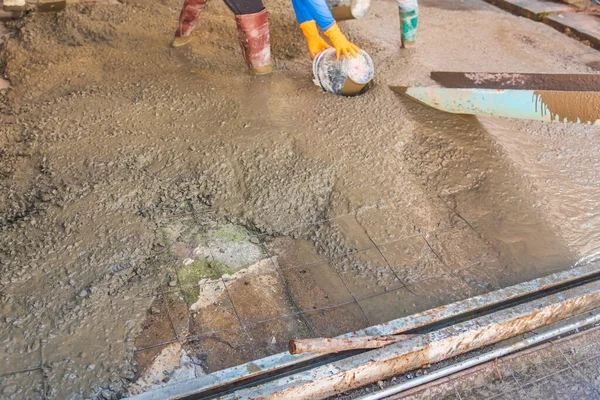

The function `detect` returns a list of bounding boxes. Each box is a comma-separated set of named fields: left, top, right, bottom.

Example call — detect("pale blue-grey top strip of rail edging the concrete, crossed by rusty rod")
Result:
left=127, top=261, right=600, bottom=400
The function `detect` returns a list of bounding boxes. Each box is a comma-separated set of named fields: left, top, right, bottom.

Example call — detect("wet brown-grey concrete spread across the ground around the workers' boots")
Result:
left=0, top=0, right=600, bottom=399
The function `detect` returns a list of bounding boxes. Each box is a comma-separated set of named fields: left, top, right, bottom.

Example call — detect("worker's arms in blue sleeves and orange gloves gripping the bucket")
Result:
left=292, top=0, right=360, bottom=59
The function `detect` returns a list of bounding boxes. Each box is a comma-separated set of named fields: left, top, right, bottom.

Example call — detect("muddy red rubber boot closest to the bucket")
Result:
left=235, top=10, right=273, bottom=75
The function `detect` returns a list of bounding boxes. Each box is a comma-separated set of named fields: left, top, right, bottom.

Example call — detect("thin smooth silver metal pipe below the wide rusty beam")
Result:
left=358, top=312, right=600, bottom=400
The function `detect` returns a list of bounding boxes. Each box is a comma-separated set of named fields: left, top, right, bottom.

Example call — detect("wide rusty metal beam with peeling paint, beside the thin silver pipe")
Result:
left=221, top=281, right=600, bottom=400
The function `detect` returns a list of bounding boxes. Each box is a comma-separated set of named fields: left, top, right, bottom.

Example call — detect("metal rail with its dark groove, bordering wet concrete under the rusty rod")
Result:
left=132, top=263, right=600, bottom=400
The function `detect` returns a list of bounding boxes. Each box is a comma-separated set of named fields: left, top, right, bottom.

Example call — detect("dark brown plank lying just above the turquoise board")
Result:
left=431, top=71, right=600, bottom=92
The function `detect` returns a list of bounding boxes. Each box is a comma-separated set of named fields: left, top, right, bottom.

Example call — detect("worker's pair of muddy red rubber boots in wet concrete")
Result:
left=173, top=0, right=272, bottom=75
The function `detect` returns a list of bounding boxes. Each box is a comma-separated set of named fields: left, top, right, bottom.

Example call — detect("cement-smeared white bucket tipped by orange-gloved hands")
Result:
left=313, top=48, right=375, bottom=96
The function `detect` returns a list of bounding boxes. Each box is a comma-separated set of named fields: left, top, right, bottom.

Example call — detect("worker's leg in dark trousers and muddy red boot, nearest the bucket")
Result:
left=225, top=0, right=272, bottom=75
